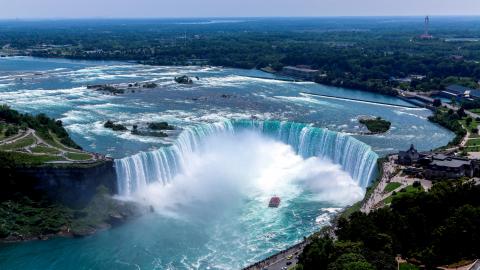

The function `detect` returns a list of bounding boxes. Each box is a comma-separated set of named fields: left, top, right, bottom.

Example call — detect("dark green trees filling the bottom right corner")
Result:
left=297, top=181, right=480, bottom=270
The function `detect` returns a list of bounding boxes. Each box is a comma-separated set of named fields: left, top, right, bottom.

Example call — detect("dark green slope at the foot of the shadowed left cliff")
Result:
left=0, top=186, right=140, bottom=240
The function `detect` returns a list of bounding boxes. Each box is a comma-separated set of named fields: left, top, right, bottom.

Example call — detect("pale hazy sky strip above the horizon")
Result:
left=0, top=0, right=480, bottom=19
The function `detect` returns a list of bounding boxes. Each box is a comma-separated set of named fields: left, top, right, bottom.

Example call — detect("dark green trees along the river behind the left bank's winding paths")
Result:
left=0, top=105, right=81, bottom=149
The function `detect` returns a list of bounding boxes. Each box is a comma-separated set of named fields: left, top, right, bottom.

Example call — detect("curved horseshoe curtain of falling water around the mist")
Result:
left=115, top=120, right=378, bottom=196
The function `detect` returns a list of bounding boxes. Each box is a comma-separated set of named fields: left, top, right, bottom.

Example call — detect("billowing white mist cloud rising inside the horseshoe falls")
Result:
left=132, top=132, right=363, bottom=217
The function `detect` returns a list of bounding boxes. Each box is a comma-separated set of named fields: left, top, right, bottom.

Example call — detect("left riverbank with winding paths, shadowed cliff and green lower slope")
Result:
left=0, top=105, right=148, bottom=243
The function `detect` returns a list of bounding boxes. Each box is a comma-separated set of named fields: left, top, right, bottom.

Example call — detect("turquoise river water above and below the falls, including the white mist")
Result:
left=0, top=57, right=453, bottom=269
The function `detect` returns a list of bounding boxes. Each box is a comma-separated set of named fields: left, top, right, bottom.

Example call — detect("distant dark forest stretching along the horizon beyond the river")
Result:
left=0, top=18, right=480, bottom=95
